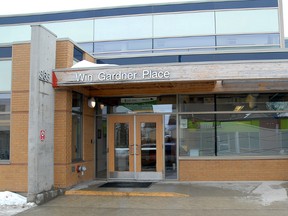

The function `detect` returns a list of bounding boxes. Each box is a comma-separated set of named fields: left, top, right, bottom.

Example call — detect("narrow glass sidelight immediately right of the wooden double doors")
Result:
left=165, top=115, right=177, bottom=179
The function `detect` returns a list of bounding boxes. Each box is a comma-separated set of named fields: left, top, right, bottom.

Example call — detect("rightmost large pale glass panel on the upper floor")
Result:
left=216, top=9, right=279, bottom=34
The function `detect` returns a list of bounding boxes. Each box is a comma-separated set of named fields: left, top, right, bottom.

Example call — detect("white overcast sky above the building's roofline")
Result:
left=0, top=0, right=288, bottom=38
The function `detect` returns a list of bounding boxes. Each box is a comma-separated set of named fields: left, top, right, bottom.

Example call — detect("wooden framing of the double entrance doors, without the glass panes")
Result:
left=107, top=114, right=164, bottom=181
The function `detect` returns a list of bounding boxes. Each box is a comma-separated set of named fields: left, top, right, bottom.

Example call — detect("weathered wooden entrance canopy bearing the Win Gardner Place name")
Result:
left=53, top=61, right=288, bottom=96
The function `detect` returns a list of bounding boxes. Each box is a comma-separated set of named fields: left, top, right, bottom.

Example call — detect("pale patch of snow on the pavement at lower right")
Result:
left=252, top=182, right=287, bottom=205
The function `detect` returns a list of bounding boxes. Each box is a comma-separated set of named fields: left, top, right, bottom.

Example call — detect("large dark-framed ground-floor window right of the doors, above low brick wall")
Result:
left=179, top=93, right=288, bottom=157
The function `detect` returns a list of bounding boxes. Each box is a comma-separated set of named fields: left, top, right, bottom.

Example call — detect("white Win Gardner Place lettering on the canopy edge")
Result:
left=75, top=70, right=170, bottom=82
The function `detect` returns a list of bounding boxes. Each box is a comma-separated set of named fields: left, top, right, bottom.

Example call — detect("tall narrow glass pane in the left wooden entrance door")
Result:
left=114, top=123, right=129, bottom=171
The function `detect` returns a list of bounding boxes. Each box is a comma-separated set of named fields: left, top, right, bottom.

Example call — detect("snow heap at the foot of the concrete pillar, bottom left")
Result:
left=0, top=191, right=36, bottom=216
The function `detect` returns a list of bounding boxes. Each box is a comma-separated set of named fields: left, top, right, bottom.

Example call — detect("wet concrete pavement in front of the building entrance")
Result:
left=18, top=181, right=288, bottom=216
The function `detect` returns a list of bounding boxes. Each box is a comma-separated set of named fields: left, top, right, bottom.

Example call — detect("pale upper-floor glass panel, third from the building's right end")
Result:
left=95, top=16, right=152, bottom=41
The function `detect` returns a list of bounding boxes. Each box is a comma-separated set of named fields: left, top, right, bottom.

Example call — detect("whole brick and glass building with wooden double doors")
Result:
left=0, top=0, right=288, bottom=199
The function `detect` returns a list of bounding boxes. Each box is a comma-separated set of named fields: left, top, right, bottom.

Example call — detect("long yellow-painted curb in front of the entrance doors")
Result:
left=65, top=190, right=189, bottom=197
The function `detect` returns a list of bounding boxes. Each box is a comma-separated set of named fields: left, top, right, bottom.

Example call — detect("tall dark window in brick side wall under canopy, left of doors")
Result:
left=72, top=92, right=83, bottom=162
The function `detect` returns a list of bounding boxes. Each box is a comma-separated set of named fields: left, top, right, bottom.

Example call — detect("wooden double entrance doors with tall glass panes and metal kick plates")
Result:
left=108, top=115, right=163, bottom=180
